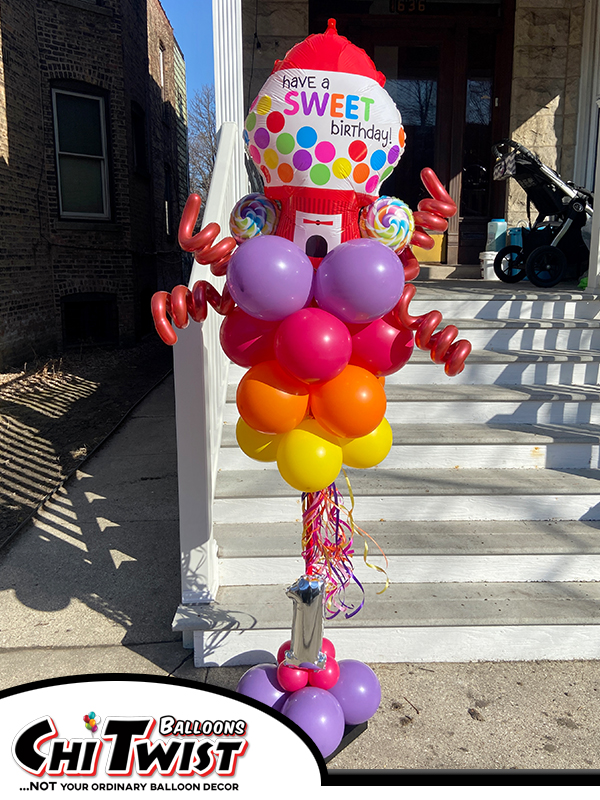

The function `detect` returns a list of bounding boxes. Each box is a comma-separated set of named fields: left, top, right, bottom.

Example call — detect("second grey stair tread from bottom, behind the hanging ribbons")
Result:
left=215, top=519, right=600, bottom=559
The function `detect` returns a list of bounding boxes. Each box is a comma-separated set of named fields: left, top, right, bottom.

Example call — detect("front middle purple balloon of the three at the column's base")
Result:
left=283, top=686, right=345, bottom=758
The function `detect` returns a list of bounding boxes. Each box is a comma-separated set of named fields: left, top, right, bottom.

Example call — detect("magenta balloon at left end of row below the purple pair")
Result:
left=220, top=306, right=279, bottom=367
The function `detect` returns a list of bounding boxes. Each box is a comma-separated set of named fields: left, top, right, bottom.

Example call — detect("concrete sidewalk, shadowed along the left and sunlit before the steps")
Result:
left=0, top=378, right=600, bottom=770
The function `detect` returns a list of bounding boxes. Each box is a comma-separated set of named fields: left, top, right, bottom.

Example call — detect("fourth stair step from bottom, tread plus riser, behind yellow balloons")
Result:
left=219, top=422, right=600, bottom=470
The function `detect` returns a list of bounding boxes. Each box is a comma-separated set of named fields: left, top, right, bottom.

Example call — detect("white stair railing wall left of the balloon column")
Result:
left=173, top=122, right=243, bottom=605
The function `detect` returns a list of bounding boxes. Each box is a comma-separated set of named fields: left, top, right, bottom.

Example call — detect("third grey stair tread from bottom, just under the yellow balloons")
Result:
left=215, top=468, right=600, bottom=500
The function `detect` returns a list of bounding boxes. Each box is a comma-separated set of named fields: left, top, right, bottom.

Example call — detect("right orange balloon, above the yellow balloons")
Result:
left=310, top=364, right=386, bottom=438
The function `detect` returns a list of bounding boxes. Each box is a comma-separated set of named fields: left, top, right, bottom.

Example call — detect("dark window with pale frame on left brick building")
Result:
left=52, top=89, right=110, bottom=219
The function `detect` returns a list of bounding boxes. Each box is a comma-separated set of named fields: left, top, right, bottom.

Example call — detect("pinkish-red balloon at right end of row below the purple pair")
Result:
left=350, top=314, right=414, bottom=376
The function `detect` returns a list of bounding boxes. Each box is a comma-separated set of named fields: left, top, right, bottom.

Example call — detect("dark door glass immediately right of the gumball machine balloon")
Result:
left=374, top=45, right=440, bottom=209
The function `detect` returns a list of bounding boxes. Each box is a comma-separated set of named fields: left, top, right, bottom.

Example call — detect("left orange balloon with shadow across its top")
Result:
left=236, top=361, right=308, bottom=434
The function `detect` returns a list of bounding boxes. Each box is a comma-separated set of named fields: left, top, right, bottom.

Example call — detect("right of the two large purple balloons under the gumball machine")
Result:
left=315, top=239, right=404, bottom=324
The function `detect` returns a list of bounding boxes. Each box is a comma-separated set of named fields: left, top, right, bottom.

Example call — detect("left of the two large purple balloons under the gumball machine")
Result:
left=227, top=236, right=316, bottom=320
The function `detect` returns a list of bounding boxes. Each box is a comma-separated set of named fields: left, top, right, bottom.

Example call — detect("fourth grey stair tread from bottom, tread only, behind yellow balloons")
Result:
left=221, top=422, right=600, bottom=450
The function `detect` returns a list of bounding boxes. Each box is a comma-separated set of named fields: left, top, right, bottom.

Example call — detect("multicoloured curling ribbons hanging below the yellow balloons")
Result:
left=302, top=472, right=389, bottom=619
